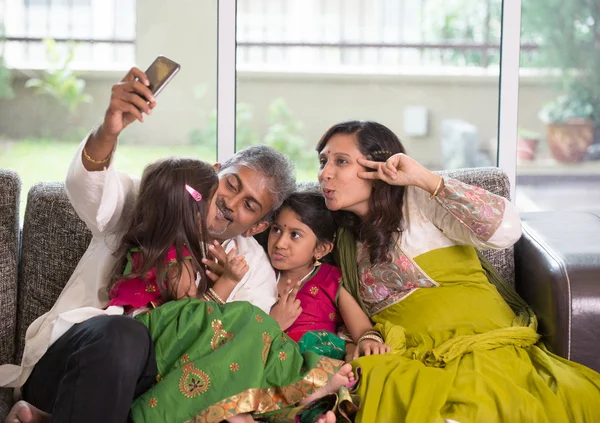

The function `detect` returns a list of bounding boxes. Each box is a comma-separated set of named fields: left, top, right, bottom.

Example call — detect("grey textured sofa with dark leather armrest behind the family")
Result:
left=0, top=168, right=600, bottom=420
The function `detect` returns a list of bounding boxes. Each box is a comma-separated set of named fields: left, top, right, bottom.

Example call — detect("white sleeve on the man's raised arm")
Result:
left=65, top=135, right=139, bottom=236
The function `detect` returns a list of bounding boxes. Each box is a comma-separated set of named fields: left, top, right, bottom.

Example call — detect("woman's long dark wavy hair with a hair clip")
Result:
left=317, top=121, right=406, bottom=265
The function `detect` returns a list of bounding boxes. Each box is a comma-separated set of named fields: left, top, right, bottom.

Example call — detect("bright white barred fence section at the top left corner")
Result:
left=4, top=0, right=136, bottom=70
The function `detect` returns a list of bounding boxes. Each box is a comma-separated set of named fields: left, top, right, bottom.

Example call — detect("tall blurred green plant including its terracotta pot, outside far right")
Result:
left=522, top=0, right=600, bottom=163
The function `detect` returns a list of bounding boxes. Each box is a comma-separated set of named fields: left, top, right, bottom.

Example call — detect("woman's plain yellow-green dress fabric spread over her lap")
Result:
left=353, top=246, right=600, bottom=423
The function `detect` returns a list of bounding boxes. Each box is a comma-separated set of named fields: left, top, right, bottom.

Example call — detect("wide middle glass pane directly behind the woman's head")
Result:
left=236, top=0, right=502, bottom=180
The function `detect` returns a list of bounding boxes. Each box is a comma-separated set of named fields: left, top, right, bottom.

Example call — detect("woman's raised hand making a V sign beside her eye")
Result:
left=358, top=153, right=440, bottom=194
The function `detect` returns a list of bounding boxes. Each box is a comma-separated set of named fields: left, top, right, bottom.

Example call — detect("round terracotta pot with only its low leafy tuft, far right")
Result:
left=540, top=92, right=595, bottom=163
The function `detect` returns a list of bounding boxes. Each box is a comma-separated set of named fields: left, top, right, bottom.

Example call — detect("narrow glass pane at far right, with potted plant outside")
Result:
left=517, top=0, right=600, bottom=211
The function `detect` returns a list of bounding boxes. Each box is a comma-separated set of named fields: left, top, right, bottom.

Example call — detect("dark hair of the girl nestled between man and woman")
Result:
left=274, top=190, right=337, bottom=264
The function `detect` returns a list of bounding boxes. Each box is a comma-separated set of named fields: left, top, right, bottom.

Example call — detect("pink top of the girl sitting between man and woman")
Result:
left=286, top=264, right=342, bottom=342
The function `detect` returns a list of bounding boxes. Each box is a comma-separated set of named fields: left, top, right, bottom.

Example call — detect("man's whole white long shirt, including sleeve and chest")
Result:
left=0, top=138, right=277, bottom=387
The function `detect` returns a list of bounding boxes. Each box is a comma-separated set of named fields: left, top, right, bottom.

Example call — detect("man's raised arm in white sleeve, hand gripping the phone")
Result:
left=65, top=68, right=156, bottom=236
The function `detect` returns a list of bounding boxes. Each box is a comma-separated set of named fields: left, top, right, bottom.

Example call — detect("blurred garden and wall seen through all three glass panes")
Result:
left=0, top=0, right=600, bottom=211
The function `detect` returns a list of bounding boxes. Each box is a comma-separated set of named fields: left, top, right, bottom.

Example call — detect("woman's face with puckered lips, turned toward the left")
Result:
left=319, top=134, right=373, bottom=218
